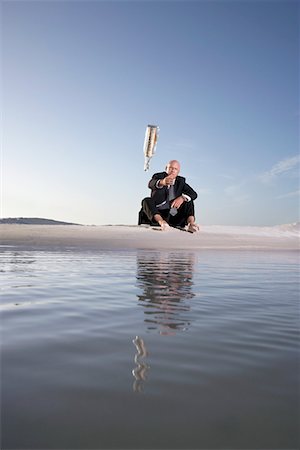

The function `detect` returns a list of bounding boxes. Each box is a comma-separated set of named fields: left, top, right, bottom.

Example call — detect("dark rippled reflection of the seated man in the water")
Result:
left=137, top=252, right=194, bottom=334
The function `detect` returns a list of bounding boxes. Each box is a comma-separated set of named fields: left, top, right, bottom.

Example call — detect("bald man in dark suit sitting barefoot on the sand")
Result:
left=139, top=160, right=199, bottom=233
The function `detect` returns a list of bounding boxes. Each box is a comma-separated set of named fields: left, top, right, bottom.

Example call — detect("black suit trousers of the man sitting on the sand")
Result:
left=142, top=197, right=195, bottom=227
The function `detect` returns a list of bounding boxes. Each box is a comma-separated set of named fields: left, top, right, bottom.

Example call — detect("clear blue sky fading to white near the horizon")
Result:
left=1, top=0, right=300, bottom=226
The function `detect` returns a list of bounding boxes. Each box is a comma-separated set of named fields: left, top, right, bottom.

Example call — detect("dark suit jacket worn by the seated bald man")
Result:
left=148, top=172, right=197, bottom=205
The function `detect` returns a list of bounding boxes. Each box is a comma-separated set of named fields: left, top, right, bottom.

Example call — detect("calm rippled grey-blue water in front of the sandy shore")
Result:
left=0, top=248, right=300, bottom=450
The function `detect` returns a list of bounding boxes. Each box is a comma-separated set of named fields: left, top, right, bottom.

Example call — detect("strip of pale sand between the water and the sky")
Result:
left=0, top=224, right=300, bottom=251
